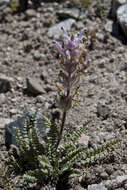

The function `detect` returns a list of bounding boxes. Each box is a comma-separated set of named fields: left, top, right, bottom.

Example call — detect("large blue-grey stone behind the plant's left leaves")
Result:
left=5, top=111, right=48, bottom=149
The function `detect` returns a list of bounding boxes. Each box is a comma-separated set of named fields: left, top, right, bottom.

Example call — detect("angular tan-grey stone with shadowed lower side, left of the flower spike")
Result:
left=26, top=78, right=45, bottom=95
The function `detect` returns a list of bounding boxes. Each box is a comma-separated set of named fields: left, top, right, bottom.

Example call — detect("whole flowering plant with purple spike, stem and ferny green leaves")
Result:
left=4, top=28, right=118, bottom=189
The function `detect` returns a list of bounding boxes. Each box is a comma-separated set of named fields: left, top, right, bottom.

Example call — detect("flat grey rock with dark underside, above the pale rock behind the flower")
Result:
left=56, top=8, right=80, bottom=19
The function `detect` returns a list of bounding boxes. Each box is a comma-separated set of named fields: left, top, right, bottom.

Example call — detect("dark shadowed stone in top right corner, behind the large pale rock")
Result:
left=111, top=0, right=127, bottom=18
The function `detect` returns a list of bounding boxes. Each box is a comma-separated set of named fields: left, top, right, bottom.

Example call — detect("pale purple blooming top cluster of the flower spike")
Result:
left=53, top=27, right=87, bottom=73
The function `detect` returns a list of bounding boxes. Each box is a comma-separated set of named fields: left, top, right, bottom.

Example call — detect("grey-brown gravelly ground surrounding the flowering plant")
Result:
left=0, top=0, right=127, bottom=190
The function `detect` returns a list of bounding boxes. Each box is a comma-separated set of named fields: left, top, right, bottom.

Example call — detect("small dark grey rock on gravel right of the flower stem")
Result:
left=97, top=103, right=109, bottom=119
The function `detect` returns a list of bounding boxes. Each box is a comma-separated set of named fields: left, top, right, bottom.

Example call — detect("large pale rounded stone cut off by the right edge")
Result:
left=117, top=4, right=127, bottom=37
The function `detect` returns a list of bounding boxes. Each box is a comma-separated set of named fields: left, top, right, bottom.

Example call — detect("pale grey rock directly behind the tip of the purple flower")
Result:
left=48, top=18, right=76, bottom=39
